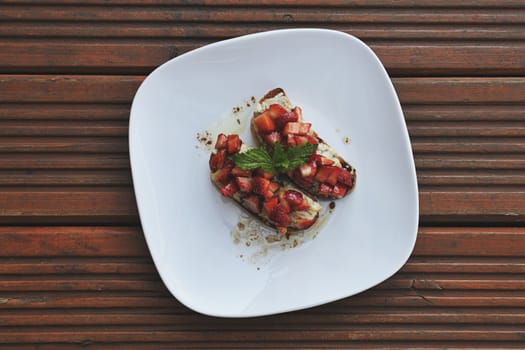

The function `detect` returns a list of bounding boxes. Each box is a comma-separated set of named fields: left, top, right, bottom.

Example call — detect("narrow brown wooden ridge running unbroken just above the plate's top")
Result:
left=0, top=5, right=525, bottom=24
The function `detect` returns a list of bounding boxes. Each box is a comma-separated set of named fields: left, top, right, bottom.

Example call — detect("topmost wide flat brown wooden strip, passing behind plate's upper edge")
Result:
left=0, top=41, right=525, bottom=76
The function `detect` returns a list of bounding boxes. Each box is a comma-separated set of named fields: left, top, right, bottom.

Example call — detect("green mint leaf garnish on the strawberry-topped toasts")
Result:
left=233, top=143, right=317, bottom=174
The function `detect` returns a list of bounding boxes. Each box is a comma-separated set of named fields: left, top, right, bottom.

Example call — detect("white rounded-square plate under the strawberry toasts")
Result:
left=129, top=29, right=418, bottom=317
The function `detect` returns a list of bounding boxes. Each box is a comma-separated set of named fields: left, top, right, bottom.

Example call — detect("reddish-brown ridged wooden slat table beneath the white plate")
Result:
left=0, top=0, right=525, bottom=349
